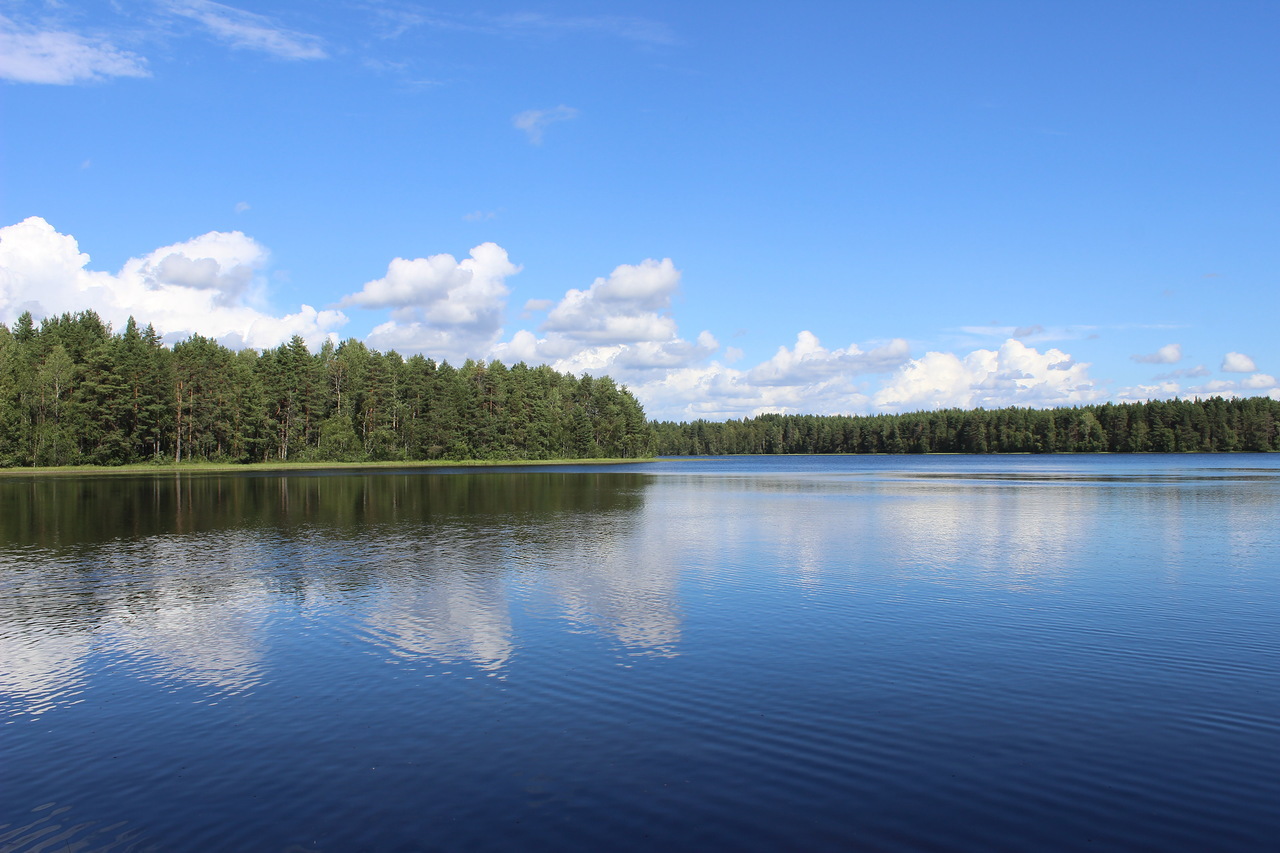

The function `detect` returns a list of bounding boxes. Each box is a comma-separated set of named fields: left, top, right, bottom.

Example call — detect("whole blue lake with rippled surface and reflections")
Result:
left=0, top=456, right=1280, bottom=850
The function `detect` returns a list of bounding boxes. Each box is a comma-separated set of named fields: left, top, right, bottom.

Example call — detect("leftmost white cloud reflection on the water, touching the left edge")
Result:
left=0, top=534, right=270, bottom=713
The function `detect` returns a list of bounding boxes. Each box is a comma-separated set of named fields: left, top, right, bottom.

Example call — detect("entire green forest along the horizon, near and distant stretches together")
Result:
left=0, top=311, right=1280, bottom=467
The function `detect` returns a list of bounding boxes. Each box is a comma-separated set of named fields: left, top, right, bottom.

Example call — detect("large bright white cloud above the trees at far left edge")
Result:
left=0, top=216, right=347, bottom=347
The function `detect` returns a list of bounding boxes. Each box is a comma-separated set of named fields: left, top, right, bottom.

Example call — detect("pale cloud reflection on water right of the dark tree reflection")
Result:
left=640, top=474, right=1098, bottom=588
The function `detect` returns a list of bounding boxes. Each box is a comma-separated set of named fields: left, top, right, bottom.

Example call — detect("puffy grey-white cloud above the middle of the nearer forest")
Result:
left=340, top=243, right=520, bottom=360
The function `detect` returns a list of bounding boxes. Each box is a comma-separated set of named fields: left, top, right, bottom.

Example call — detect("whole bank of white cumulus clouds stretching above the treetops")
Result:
left=0, top=216, right=1280, bottom=420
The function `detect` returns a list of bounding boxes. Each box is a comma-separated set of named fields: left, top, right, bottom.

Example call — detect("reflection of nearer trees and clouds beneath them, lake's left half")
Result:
left=0, top=471, right=680, bottom=702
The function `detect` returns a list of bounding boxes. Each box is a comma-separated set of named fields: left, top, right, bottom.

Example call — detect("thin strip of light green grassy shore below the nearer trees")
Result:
left=0, top=456, right=654, bottom=476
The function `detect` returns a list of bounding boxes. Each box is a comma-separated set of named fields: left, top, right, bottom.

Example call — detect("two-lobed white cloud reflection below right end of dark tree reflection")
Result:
left=364, top=504, right=680, bottom=670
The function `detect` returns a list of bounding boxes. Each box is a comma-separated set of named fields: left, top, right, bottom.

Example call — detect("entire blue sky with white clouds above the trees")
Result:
left=0, top=0, right=1280, bottom=420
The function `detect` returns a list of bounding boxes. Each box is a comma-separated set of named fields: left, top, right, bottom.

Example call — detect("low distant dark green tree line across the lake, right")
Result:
left=654, top=397, right=1280, bottom=456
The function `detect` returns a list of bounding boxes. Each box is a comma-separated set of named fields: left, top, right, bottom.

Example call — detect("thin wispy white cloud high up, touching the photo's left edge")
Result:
left=0, top=15, right=148, bottom=86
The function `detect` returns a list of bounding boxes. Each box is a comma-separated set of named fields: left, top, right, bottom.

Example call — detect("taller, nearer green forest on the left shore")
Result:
left=0, top=311, right=653, bottom=466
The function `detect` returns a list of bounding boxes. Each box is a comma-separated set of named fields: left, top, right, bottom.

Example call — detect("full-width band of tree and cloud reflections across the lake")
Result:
left=0, top=471, right=1275, bottom=713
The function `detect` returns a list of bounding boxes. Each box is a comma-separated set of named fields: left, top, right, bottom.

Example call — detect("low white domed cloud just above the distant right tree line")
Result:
left=873, top=338, right=1102, bottom=411
